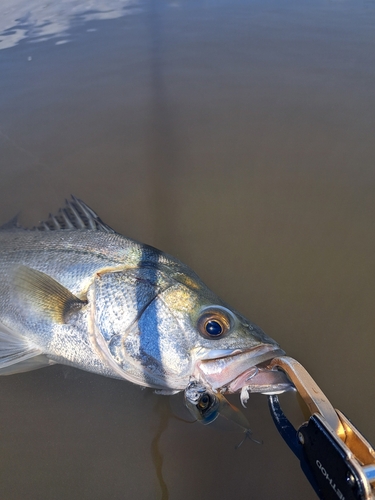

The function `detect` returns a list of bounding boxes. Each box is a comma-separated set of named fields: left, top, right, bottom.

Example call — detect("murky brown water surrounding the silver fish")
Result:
left=0, top=0, right=375, bottom=500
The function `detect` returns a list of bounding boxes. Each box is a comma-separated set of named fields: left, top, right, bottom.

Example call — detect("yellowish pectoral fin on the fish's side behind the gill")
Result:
left=14, top=266, right=87, bottom=323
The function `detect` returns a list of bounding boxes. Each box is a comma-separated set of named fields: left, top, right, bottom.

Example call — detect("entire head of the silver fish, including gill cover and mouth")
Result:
left=89, top=261, right=284, bottom=393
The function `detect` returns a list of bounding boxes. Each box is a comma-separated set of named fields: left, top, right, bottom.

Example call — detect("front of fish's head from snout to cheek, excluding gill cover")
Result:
left=163, top=268, right=291, bottom=394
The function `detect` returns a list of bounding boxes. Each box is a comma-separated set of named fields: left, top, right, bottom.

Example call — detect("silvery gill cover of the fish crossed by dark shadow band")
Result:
left=88, top=266, right=189, bottom=389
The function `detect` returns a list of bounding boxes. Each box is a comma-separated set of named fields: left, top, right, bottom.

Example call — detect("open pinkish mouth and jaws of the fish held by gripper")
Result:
left=194, top=344, right=293, bottom=394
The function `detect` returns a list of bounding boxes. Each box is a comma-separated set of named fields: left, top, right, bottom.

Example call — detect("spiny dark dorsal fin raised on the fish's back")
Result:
left=33, top=195, right=115, bottom=233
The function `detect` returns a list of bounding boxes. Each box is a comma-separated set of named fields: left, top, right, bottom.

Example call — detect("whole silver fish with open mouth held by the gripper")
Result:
left=0, top=196, right=291, bottom=406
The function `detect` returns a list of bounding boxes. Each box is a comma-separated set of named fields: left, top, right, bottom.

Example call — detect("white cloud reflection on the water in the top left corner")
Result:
left=0, top=0, right=137, bottom=50
